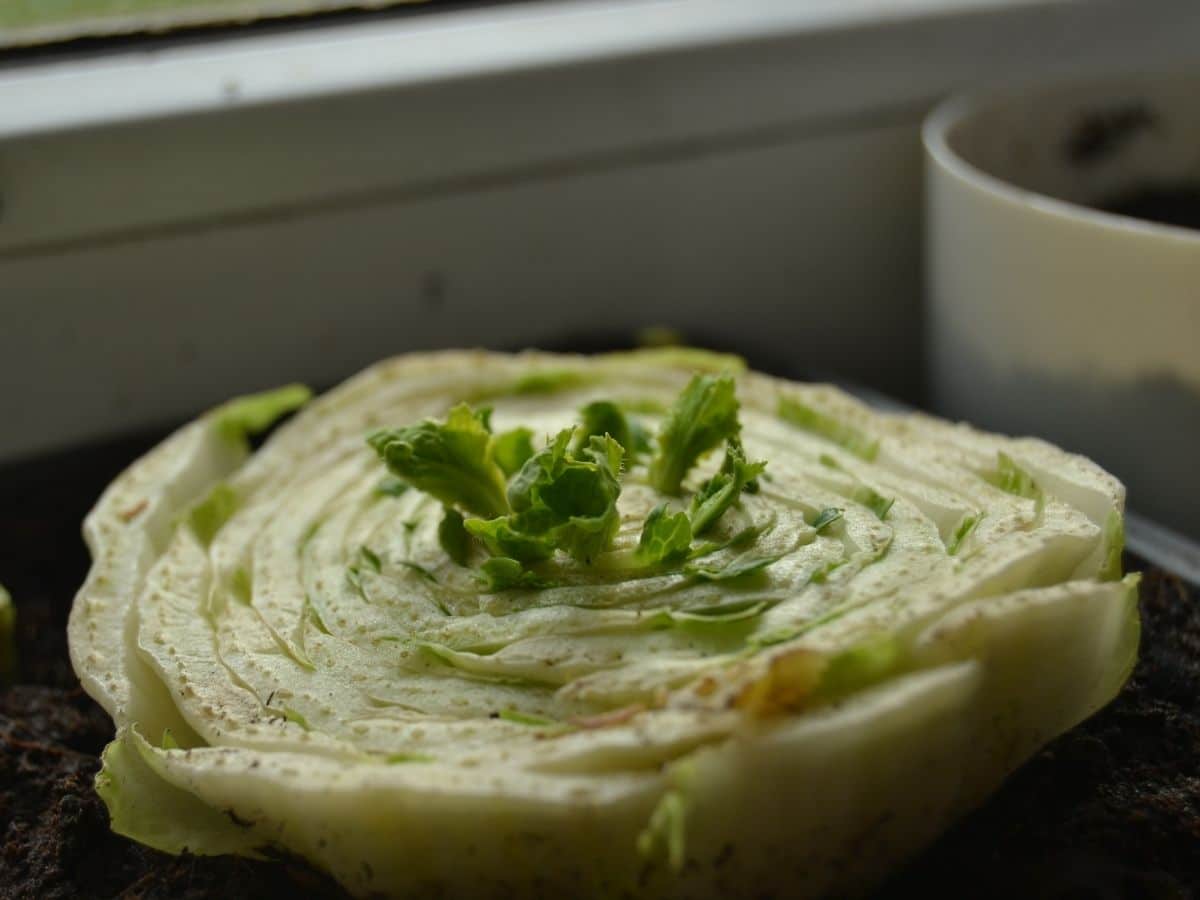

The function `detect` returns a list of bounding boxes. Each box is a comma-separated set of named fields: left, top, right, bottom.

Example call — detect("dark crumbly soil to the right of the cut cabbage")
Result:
left=882, top=566, right=1200, bottom=900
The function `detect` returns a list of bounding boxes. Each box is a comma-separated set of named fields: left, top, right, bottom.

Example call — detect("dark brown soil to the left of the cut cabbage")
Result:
left=0, top=430, right=343, bottom=900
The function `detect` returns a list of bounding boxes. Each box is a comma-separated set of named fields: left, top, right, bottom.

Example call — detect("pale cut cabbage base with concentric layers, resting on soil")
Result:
left=70, top=350, right=1138, bottom=898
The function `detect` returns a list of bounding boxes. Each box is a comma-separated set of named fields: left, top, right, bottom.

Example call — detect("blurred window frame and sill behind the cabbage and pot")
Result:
left=0, top=0, right=1200, bottom=542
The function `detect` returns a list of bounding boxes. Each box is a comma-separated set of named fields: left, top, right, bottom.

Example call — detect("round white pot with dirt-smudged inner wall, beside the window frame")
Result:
left=924, top=72, right=1200, bottom=535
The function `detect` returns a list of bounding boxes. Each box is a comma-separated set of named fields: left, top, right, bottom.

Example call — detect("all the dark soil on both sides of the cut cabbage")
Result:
left=0, top=437, right=1200, bottom=900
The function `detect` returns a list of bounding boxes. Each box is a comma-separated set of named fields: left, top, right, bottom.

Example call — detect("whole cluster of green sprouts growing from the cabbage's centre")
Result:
left=372, top=374, right=774, bottom=590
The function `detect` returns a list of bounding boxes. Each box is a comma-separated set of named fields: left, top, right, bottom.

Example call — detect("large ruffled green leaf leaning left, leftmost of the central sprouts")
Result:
left=367, top=403, right=509, bottom=516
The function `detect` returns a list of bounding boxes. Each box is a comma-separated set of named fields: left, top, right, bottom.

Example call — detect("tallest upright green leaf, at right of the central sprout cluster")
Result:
left=650, top=374, right=740, bottom=494
